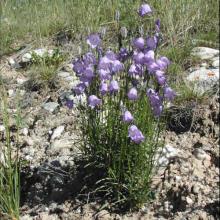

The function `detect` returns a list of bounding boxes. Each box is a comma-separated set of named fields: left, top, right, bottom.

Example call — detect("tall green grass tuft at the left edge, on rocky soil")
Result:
left=0, top=91, right=20, bottom=219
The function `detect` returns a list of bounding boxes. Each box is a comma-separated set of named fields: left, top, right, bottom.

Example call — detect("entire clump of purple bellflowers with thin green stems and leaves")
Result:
left=68, top=4, right=175, bottom=210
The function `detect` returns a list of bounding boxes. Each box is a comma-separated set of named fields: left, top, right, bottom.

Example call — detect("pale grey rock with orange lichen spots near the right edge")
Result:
left=186, top=68, right=219, bottom=94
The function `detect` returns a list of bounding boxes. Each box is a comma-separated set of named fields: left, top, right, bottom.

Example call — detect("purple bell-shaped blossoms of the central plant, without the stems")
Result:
left=71, top=4, right=175, bottom=144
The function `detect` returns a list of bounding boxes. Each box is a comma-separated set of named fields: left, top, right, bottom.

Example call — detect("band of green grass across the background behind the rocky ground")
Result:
left=0, top=0, right=219, bottom=55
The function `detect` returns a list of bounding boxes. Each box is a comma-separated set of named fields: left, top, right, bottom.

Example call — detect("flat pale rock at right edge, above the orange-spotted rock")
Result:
left=192, top=47, right=219, bottom=60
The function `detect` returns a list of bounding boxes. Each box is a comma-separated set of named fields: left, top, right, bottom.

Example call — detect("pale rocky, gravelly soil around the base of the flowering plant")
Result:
left=0, top=41, right=219, bottom=220
